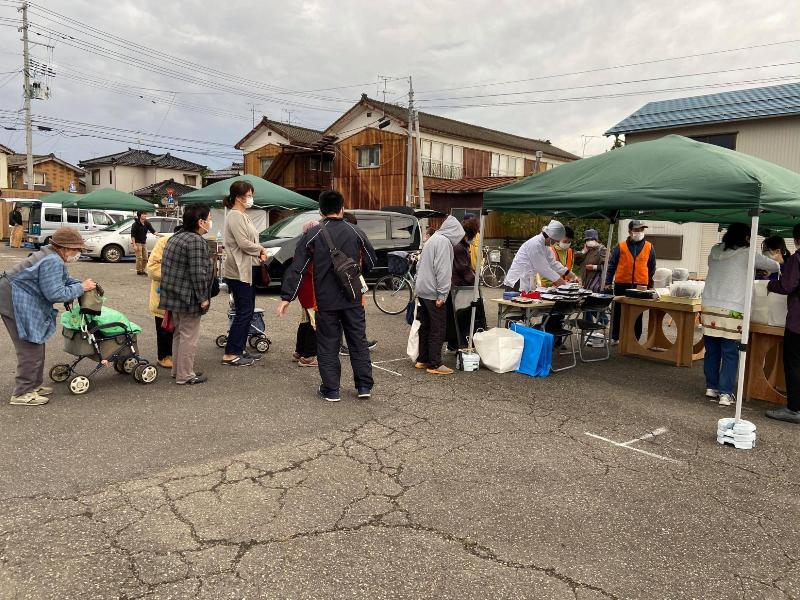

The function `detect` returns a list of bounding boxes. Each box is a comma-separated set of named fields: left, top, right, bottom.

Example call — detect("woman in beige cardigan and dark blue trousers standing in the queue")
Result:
left=222, top=180, right=267, bottom=367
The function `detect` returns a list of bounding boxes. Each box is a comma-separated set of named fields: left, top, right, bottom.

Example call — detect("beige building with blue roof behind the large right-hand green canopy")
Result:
left=606, top=83, right=800, bottom=277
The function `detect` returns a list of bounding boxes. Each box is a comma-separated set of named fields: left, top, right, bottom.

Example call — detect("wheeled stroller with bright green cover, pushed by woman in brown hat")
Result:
left=50, top=291, right=158, bottom=395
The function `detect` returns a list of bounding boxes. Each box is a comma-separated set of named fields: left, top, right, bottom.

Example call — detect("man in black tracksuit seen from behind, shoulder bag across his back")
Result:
left=278, top=191, right=377, bottom=402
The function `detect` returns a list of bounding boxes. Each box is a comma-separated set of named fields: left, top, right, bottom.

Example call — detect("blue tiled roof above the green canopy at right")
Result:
left=606, top=83, right=800, bottom=135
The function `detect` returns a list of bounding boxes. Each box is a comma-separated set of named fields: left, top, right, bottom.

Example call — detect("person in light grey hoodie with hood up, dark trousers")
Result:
left=415, top=216, right=464, bottom=375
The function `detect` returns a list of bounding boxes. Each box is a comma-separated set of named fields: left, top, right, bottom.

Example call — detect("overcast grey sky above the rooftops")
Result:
left=0, top=0, right=800, bottom=168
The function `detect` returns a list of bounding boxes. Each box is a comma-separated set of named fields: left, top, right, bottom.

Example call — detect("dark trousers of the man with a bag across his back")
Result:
left=317, top=306, right=373, bottom=392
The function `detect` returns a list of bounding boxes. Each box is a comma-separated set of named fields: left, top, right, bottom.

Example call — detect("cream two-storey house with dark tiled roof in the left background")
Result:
left=80, top=148, right=206, bottom=192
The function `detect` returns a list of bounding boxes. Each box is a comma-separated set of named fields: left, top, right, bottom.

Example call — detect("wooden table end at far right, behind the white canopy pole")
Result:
left=744, top=323, right=786, bottom=404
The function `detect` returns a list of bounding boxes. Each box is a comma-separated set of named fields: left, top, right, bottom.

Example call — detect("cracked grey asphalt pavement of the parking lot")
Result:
left=0, top=247, right=800, bottom=600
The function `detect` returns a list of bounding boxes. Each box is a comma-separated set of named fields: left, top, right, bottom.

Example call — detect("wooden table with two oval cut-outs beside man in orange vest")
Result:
left=614, top=296, right=705, bottom=367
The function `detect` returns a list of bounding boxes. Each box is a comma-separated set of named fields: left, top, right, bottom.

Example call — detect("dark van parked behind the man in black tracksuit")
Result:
left=260, top=210, right=421, bottom=285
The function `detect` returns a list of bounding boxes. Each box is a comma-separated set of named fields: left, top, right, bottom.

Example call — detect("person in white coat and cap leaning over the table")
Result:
left=503, top=221, right=577, bottom=291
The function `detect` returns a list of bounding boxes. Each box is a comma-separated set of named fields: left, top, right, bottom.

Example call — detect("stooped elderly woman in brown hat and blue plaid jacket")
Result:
left=0, top=227, right=95, bottom=406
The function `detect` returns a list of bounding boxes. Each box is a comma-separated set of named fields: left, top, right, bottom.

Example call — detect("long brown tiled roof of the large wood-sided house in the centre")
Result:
left=328, top=94, right=580, bottom=160
